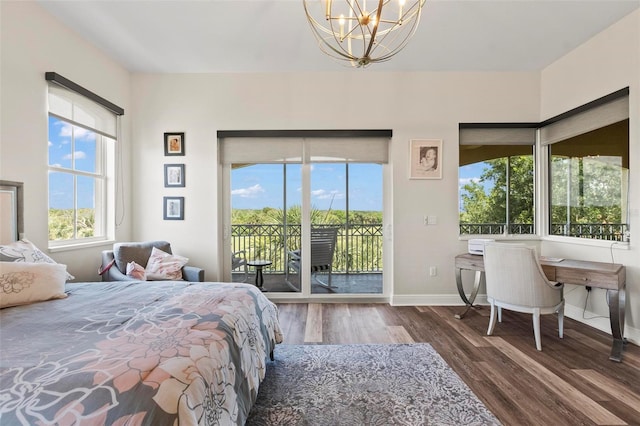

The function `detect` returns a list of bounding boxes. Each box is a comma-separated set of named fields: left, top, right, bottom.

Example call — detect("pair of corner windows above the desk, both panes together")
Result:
left=459, top=88, right=629, bottom=241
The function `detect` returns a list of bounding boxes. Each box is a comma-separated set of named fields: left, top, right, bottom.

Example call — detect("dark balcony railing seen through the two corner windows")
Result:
left=459, top=223, right=629, bottom=241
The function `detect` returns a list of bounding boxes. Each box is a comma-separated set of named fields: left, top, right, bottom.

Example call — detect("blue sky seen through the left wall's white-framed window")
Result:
left=49, top=116, right=96, bottom=209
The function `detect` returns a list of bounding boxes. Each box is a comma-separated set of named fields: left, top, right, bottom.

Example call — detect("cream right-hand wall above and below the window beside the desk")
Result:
left=540, top=11, right=640, bottom=343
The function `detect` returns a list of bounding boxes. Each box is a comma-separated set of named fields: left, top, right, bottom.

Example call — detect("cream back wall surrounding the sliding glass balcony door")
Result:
left=132, top=67, right=540, bottom=296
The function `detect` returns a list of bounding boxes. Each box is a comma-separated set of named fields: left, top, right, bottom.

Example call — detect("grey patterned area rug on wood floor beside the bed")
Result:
left=246, top=343, right=500, bottom=426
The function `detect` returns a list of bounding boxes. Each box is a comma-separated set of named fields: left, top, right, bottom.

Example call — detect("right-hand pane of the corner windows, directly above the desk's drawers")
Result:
left=541, top=91, right=629, bottom=241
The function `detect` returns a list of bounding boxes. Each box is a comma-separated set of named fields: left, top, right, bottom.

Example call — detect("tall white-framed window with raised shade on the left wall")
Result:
left=47, top=73, right=122, bottom=247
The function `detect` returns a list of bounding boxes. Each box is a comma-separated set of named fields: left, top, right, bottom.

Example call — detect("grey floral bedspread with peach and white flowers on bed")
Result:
left=0, top=281, right=282, bottom=426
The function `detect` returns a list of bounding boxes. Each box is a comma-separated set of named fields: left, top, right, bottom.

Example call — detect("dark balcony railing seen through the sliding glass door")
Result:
left=231, top=224, right=383, bottom=274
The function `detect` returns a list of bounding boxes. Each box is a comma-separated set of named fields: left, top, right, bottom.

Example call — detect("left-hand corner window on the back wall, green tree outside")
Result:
left=458, top=123, right=536, bottom=235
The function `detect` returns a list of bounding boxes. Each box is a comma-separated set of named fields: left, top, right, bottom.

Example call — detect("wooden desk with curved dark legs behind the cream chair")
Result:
left=455, top=253, right=627, bottom=362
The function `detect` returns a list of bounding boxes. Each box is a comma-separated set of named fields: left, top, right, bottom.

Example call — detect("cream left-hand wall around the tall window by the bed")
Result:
left=0, top=1, right=131, bottom=280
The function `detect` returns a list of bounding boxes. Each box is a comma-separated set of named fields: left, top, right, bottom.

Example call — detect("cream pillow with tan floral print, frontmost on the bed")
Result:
left=0, top=262, right=67, bottom=308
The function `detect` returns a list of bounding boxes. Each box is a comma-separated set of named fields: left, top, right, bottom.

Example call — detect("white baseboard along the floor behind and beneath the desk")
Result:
left=390, top=294, right=640, bottom=346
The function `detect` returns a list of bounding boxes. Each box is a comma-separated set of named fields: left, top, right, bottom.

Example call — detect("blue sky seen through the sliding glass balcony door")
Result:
left=231, top=163, right=382, bottom=211
